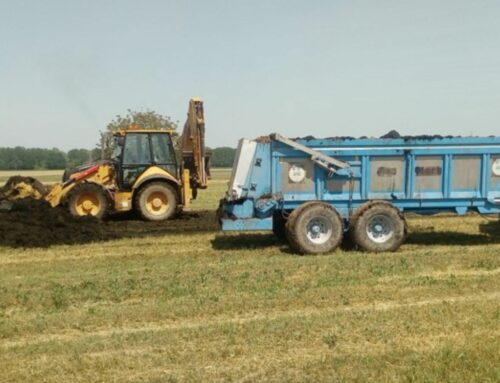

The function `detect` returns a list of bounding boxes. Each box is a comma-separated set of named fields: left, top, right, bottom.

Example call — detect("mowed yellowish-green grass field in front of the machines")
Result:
left=0, top=172, right=500, bottom=382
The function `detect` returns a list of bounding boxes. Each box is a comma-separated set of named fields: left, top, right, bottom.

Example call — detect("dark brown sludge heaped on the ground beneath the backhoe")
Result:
left=0, top=199, right=217, bottom=248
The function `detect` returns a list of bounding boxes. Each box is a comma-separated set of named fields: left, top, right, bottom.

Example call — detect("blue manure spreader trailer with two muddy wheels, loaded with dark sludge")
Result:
left=218, top=134, right=500, bottom=254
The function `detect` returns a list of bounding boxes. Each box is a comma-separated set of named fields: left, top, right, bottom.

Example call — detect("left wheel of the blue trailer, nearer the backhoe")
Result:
left=286, top=202, right=344, bottom=254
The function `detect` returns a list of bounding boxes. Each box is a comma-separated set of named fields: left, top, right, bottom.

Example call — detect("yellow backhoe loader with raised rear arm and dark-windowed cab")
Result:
left=0, top=98, right=209, bottom=221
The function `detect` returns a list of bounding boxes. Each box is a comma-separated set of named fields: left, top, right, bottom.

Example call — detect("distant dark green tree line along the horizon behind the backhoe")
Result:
left=0, top=146, right=236, bottom=170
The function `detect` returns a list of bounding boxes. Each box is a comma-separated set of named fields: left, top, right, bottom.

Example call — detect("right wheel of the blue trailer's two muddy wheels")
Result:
left=350, top=201, right=407, bottom=253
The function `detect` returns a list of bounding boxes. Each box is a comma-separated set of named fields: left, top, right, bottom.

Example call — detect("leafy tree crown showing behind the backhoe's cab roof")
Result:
left=98, top=109, right=177, bottom=157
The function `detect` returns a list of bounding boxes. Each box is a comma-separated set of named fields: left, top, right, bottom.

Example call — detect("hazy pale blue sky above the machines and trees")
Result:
left=0, top=0, right=500, bottom=150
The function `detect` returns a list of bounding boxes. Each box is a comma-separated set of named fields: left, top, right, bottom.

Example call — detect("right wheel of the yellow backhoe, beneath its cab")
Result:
left=134, top=182, right=179, bottom=221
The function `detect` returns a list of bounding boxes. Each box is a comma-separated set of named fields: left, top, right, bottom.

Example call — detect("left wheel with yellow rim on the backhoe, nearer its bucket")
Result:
left=67, top=182, right=110, bottom=219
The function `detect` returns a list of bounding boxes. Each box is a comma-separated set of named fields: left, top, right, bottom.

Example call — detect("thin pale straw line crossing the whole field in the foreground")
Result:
left=0, top=291, right=500, bottom=349
